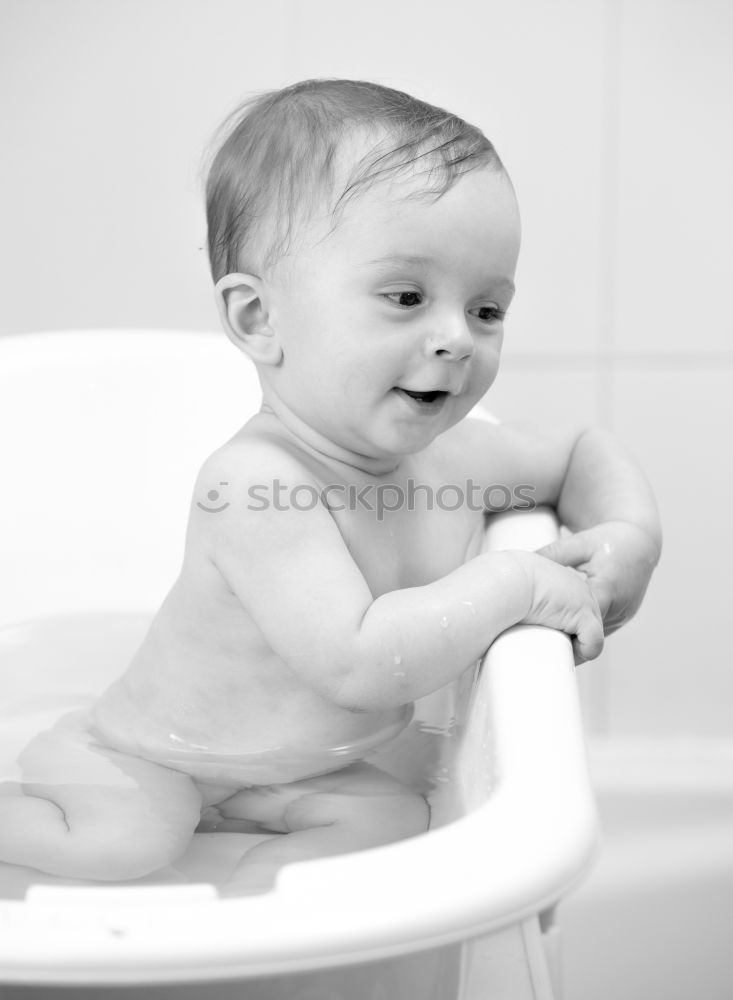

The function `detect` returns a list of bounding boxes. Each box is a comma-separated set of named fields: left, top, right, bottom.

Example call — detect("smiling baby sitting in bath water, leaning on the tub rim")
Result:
left=0, top=80, right=661, bottom=892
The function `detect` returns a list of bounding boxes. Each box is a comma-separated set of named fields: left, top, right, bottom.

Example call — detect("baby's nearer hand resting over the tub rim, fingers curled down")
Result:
left=512, top=552, right=603, bottom=663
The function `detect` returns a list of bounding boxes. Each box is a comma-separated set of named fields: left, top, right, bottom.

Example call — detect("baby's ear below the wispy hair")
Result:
left=214, top=274, right=282, bottom=365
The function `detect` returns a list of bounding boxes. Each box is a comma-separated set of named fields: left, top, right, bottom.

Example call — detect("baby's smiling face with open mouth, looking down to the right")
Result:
left=270, top=169, right=520, bottom=465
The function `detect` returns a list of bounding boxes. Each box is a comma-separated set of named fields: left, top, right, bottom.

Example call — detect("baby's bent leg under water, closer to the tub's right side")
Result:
left=218, top=764, right=430, bottom=895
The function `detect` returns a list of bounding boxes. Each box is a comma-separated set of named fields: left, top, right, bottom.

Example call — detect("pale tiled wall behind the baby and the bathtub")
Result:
left=0, top=0, right=733, bottom=736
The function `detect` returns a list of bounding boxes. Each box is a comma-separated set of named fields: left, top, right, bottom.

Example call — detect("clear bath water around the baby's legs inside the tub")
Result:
left=0, top=614, right=474, bottom=898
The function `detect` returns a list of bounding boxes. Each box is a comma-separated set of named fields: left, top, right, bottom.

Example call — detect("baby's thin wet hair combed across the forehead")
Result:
left=206, top=79, right=504, bottom=281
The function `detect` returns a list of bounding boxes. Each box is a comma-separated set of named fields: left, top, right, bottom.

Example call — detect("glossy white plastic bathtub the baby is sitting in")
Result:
left=0, top=331, right=597, bottom=1000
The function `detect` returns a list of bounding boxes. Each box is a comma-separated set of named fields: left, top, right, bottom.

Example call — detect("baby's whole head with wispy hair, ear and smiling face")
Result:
left=207, top=80, right=519, bottom=468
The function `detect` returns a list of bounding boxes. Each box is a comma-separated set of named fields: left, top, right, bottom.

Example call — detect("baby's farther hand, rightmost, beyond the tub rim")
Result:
left=538, top=521, right=659, bottom=635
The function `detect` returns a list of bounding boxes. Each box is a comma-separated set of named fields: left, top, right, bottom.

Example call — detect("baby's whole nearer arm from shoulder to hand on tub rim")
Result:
left=204, top=445, right=603, bottom=711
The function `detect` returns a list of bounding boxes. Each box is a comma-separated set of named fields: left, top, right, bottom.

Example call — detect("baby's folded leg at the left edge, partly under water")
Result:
left=0, top=714, right=201, bottom=880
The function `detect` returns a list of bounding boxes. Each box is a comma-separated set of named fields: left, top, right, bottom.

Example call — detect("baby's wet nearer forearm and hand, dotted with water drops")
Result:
left=341, top=551, right=603, bottom=708
